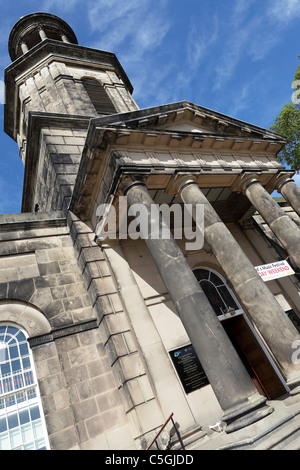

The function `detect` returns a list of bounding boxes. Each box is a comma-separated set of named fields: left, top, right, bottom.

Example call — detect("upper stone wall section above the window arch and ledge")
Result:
left=0, top=212, right=93, bottom=329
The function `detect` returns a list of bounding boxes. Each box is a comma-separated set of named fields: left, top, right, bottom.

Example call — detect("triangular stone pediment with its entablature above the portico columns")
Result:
left=71, top=102, right=284, bottom=217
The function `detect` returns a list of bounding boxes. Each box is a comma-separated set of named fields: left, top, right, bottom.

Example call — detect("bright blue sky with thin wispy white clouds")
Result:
left=0, top=0, right=300, bottom=214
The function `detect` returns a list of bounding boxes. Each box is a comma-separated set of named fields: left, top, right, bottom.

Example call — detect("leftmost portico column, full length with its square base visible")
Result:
left=123, top=177, right=273, bottom=432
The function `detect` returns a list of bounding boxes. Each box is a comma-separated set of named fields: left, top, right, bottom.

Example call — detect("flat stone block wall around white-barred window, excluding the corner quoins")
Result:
left=0, top=212, right=135, bottom=449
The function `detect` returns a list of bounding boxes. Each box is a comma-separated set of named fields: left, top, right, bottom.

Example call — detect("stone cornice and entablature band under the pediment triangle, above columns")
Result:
left=70, top=118, right=283, bottom=218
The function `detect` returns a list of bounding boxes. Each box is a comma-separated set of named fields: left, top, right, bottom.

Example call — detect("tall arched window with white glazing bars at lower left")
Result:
left=0, top=324, right=49, bottom=450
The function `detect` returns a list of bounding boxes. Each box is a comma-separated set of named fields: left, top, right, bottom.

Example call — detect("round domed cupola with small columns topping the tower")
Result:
left=8, top=13, right=78, bottom=61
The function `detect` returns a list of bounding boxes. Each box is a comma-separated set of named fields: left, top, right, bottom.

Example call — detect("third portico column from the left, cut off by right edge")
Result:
left=240, top=175, right=300, bottom=268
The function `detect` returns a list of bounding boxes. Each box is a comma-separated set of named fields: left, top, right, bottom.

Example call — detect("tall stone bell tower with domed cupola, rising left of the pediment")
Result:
left=4, top=13, right=138, bottom=212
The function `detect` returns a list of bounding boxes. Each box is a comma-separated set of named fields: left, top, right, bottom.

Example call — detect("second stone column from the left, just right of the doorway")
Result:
left=175, top=176, right=300, bottom=393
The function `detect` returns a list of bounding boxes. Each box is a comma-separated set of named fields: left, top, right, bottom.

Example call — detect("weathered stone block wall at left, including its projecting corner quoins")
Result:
left=0, top=211, right=171, bottom=449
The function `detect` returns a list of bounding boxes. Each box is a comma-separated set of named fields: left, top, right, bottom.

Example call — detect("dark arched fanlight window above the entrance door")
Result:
left=194, top=268, right=241, bottom=317
